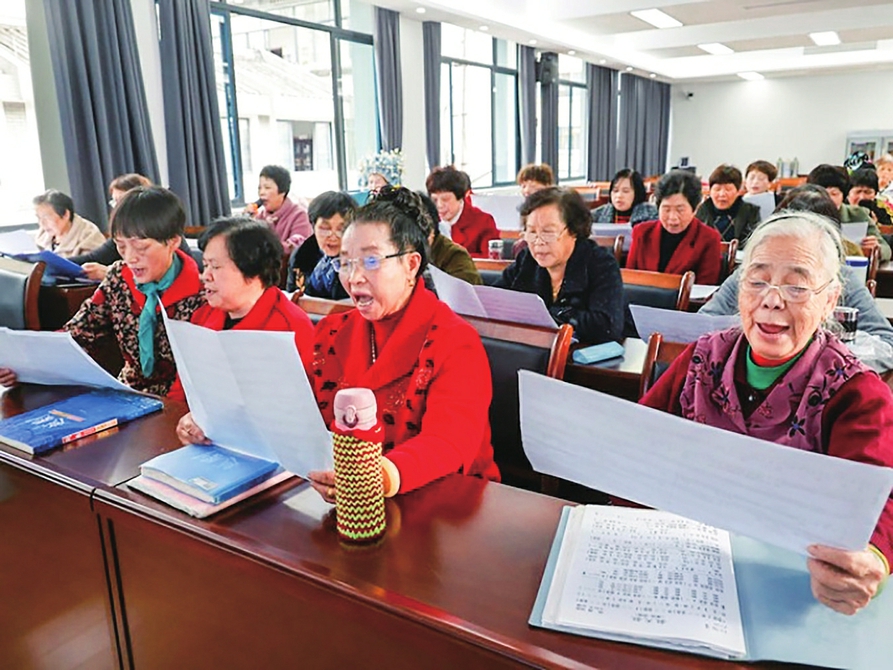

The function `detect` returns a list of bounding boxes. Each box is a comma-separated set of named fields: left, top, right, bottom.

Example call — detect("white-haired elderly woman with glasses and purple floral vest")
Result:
left=642, top=212, right=893, bottom=614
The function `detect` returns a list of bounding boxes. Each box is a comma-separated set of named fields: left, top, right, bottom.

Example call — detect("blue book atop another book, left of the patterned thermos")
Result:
left=140, top=444, right=280, bottom=505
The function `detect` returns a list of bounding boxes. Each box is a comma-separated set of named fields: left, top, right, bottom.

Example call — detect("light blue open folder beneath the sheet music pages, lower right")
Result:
left=528, top=507, right=893, bottom=670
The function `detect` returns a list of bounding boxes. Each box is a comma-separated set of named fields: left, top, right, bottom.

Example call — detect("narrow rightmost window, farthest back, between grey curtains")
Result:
left=558, top=54, right=588, bottom=179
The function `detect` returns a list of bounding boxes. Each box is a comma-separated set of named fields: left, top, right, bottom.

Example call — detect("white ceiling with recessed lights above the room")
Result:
left=376, top=0, right=893, bottom=85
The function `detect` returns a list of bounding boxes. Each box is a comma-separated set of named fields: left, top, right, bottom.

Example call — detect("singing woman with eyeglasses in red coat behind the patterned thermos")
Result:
left=310, top=186, right=499, bottom=502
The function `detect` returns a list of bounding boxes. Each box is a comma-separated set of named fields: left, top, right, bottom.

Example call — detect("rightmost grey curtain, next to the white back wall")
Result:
left=617, top=74, right=670, bottom=176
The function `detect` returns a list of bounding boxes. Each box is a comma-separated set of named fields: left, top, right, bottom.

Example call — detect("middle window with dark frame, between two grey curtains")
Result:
left=440, top=29, right=520, bottom=187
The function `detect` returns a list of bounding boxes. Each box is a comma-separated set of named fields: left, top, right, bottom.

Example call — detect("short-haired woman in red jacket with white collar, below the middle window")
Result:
left=425, top=165, right=499, bottom=258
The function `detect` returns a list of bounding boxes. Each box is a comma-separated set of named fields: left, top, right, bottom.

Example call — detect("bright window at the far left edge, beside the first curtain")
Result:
left=0, top=0, right=44, bottom=226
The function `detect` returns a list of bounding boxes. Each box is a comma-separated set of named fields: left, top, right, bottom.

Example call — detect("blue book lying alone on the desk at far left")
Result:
left=0, top=389, right=164, bottom=454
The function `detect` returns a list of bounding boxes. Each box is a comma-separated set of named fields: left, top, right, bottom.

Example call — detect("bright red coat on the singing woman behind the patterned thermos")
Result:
left=312, top=283, right=499, bottom=493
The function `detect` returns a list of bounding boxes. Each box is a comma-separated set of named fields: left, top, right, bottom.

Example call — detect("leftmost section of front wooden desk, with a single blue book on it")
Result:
left=0, top=385, right=185, bottom=668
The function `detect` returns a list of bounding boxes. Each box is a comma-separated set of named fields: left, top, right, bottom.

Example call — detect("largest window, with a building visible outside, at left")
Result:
left=211, top=0, right=378, bottom=204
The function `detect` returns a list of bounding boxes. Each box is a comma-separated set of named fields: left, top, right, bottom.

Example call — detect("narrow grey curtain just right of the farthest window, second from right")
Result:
left=586, top=63, right=618, bottom=181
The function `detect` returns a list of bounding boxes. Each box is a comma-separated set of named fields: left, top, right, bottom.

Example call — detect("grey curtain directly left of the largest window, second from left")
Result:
left=156, top=0, right=230, bottom=226
